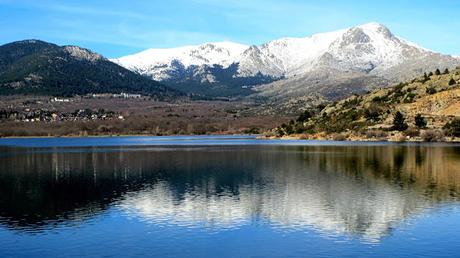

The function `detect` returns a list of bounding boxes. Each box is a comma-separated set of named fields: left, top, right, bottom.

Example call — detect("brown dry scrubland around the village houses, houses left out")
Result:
left=0, top=97, right=291, bottom=136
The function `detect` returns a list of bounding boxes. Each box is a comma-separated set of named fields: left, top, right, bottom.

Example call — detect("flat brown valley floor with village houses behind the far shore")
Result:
left=0, top=96, right=293, bottom=137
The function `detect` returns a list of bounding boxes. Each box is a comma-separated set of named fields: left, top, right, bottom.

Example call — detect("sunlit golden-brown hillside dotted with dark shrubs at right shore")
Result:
left=272, top=67, right=460, bottom=141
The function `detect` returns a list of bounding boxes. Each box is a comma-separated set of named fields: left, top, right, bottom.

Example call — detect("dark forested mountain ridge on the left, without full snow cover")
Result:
left=0, top=39, right=180, bottom=98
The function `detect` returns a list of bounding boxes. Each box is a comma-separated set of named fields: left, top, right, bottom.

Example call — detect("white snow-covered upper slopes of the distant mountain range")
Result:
left=113, top=22, right=416, bottom=80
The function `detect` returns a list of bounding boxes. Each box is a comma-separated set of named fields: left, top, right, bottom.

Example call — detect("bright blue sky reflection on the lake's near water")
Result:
left=0, top=205, right=460, bottom=257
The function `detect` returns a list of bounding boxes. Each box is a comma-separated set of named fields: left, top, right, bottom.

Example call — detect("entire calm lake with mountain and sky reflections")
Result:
left=0, top=136, right=460, bottom=257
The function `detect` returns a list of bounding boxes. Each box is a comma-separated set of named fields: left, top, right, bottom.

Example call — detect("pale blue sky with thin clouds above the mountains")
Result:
left=0, top=0, right=460, bottom=57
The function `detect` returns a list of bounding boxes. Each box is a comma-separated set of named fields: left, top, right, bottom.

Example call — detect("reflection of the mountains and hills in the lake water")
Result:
left=0, top=145, right=460, bottom=242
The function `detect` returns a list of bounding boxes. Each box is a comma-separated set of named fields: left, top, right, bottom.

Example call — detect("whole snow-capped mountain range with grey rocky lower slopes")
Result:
left=112, top=23, right=460, bottom=98
